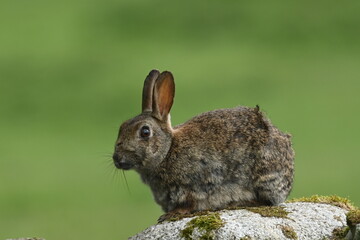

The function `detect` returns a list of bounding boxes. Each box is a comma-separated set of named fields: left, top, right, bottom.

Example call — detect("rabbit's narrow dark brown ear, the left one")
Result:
left=142, top=70, right=160, bottom=112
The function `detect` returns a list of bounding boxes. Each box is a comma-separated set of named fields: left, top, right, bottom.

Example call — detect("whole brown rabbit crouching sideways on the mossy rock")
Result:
left=113, top=70, right=294, bottom=220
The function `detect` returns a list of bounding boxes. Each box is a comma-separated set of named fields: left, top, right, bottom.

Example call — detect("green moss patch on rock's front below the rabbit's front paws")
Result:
left=181, top=212, right=224, bottom=240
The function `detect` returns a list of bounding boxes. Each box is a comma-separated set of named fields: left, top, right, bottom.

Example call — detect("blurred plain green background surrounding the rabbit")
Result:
left=0, top=0, right=360, bottom=240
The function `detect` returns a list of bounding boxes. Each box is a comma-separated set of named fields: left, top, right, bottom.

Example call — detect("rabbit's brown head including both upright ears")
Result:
left=113, top=70, right=175, bottom=172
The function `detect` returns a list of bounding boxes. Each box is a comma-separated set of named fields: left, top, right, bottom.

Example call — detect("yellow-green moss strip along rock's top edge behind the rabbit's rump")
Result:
left=287, top=195, right=356, bottom=211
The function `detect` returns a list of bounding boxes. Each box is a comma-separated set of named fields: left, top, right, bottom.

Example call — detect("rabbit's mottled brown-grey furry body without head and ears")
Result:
left=152, top=107, right=293, bottom=211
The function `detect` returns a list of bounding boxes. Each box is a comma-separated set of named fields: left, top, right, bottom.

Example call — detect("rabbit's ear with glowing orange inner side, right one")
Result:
left=152, top=71, right=175, bottom=121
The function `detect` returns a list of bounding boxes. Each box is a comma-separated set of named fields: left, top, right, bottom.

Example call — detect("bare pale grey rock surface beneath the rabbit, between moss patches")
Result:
left=129, top=202, right=347, bottom=240
